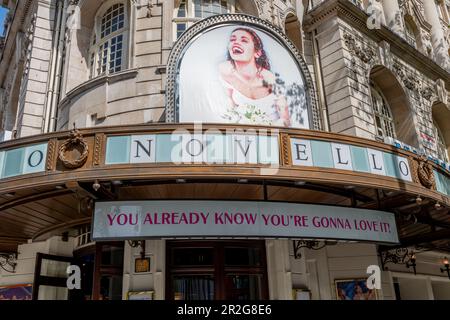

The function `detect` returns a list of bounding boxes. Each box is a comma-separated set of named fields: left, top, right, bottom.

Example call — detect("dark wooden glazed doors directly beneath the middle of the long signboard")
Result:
left=166, top=241, right=268, bottom=300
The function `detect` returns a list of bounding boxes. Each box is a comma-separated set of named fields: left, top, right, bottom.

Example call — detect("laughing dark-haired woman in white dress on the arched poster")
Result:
left=219, top=27, right=291, bottom=127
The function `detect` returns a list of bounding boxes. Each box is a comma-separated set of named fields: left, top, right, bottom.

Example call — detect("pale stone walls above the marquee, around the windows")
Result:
left=1, top=1, right=450, bottom=158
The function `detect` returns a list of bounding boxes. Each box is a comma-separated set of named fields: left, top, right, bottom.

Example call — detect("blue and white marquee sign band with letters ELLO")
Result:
left=291, top=139, right=412, bottom=182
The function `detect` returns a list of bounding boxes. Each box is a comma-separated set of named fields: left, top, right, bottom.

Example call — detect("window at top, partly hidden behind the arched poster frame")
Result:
left=173, top=0, right=257, bottom=40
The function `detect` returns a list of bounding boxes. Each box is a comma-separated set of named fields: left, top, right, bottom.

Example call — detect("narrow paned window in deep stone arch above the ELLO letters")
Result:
left=370, top=83, right=396, bottom=138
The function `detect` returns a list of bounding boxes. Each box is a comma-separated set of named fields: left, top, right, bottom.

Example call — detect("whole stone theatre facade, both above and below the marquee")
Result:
left=0, top=0, right=450, bottom=299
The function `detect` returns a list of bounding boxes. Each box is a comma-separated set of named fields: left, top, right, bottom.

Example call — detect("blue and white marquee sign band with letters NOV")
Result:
left=105, top=134, right=279, bottom=165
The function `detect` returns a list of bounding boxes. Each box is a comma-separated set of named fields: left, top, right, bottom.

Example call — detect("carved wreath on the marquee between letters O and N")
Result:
left=58, top=129, right=89, bottom=169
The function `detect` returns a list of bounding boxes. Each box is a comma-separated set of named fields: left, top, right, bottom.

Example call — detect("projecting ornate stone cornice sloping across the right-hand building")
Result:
left=303, top=0, right=450, bottom=90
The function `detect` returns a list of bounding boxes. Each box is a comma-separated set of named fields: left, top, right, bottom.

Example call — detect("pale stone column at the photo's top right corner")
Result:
left=423, top=0, right=450, bottom=70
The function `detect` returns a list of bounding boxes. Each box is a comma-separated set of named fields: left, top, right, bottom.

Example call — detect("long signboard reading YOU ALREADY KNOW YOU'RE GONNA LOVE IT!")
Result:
left=92, top=200, right=399, bottom=244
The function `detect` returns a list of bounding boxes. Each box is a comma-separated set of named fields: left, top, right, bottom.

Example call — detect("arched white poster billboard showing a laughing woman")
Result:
left=175, top=16, right=311, bottom=129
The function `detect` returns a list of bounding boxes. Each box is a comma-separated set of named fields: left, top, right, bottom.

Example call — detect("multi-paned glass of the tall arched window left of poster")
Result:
left=90, top=3, right=126, bottom=77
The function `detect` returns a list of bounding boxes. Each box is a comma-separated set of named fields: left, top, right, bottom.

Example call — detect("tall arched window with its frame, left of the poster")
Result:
left=89, top=1, right=128, bottom=78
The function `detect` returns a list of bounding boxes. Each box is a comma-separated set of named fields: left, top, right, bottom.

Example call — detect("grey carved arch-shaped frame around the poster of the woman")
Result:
left=166, top=14, right=321, bottom=130
